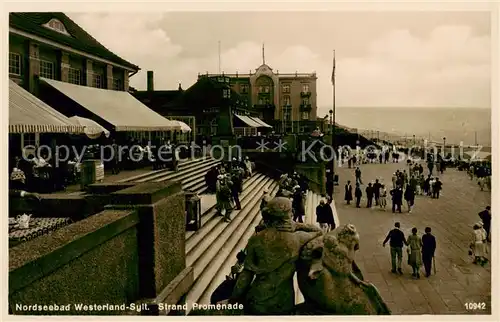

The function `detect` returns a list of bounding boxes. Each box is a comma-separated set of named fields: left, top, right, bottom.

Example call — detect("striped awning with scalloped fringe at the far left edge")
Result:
left=9, top=80, right=84, bottom=133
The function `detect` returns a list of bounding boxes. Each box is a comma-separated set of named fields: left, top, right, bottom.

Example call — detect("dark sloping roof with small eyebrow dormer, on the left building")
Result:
left=9, top=12, right=140, bottom=70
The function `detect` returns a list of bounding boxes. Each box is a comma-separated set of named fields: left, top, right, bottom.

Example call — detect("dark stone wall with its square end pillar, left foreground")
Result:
left=9, top=182, right=193, bottom=315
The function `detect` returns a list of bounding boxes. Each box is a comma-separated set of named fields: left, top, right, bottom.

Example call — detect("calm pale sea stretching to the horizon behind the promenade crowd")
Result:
left=328, top=107, right=491, bottom=147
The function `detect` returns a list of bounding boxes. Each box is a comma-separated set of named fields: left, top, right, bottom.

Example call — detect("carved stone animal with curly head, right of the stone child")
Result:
left=297, top=224, right=390, bottom=315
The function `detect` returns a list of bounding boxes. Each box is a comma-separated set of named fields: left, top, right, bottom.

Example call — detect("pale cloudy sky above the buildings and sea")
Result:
left=68, top=11, right=491, bottom=115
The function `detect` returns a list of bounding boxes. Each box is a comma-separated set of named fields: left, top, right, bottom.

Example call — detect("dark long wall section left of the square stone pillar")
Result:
left=9, top=210, right=139, bottom=315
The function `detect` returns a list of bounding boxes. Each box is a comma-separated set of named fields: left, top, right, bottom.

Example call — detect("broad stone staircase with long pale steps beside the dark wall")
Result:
left=121, top=158, right=338, bottom=314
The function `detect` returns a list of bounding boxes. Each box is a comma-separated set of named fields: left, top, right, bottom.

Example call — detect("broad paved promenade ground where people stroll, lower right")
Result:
left=334, top=163, right=491, bottom=314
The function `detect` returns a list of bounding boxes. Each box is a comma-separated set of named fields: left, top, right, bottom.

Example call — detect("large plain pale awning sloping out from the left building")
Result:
left=40, top=78, right=181, bottom=132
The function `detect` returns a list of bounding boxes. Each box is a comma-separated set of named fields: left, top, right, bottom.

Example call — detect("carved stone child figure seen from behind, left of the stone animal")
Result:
left=230, top=197, right=321, bottom=315
